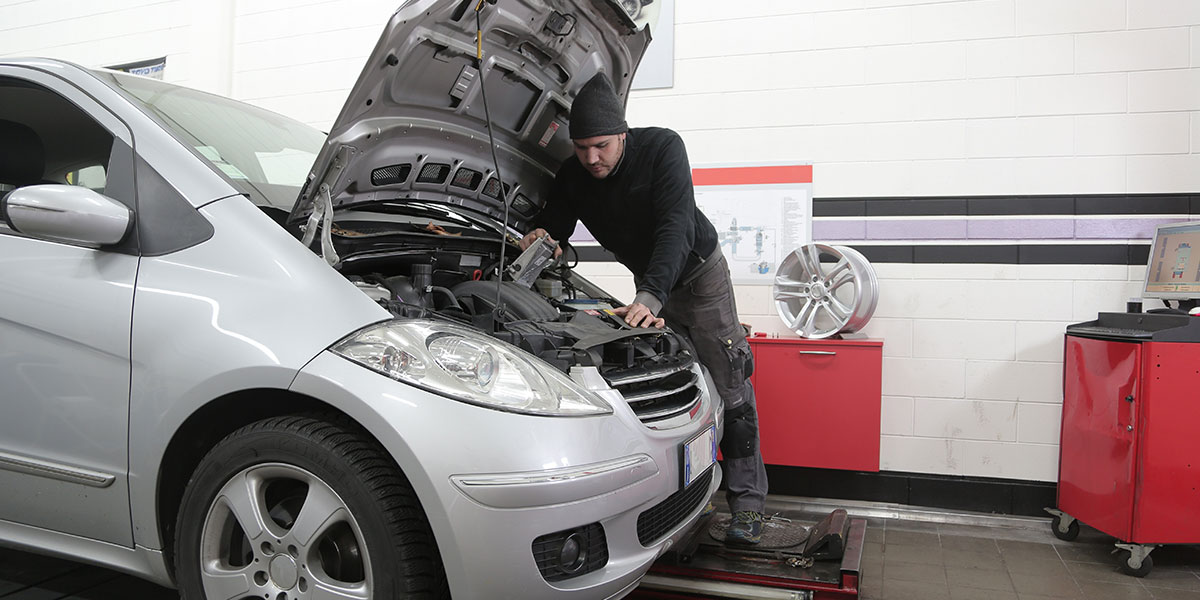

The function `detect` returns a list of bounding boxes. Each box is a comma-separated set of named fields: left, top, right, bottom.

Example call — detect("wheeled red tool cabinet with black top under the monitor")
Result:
left=1051, top=319, right=1200, bottom=576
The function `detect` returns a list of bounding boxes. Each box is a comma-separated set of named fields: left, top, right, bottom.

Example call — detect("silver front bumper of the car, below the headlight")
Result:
left=293, top=353, right=721, bottom=600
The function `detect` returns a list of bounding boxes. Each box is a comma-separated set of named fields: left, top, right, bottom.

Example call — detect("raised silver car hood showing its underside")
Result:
left=292, top=0, right=658, bottom=230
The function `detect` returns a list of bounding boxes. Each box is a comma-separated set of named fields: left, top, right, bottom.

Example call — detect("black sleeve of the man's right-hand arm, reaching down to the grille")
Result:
left=637, top=132, right=696, bottom=316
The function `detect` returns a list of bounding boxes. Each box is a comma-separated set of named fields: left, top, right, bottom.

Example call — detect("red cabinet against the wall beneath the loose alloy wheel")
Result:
left=750, top=337, right=883, bottom=472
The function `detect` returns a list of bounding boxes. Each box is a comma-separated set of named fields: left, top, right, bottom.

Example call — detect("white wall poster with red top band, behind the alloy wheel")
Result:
left=691, top=164, right=812, bottom=284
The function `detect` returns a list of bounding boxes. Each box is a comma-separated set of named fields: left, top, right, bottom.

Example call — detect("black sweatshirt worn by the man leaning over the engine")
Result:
left=534, top=127, right=716, bottom=314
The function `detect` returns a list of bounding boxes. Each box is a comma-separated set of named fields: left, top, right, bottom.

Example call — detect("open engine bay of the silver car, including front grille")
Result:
left=331, top=205, right=700, bottom=424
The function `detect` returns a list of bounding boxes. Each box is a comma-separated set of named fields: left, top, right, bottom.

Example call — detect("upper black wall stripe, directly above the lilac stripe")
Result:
left=812, top=193, right=1200, bottom=217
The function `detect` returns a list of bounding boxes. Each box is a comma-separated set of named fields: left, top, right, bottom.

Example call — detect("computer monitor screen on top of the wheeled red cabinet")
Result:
left=1142, top=222, right=1200, bottom=300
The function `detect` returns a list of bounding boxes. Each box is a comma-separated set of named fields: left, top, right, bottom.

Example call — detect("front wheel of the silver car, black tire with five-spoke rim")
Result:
left=175, top=416, right=450, bottom=600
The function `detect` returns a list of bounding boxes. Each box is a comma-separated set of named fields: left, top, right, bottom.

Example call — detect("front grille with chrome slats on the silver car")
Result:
left=605, top=360, right=700, bottom=424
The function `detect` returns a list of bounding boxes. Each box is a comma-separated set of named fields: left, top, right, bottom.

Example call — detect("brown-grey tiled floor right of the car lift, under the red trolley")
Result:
left=859, top=511, right=1200, bottom=600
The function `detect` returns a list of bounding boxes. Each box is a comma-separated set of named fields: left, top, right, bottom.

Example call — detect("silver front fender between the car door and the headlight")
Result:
left=130, top=196, right=390, bottom=548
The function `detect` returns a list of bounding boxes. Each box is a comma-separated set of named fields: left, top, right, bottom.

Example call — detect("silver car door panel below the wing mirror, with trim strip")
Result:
left=0, top=235, right=138, bottom=546
